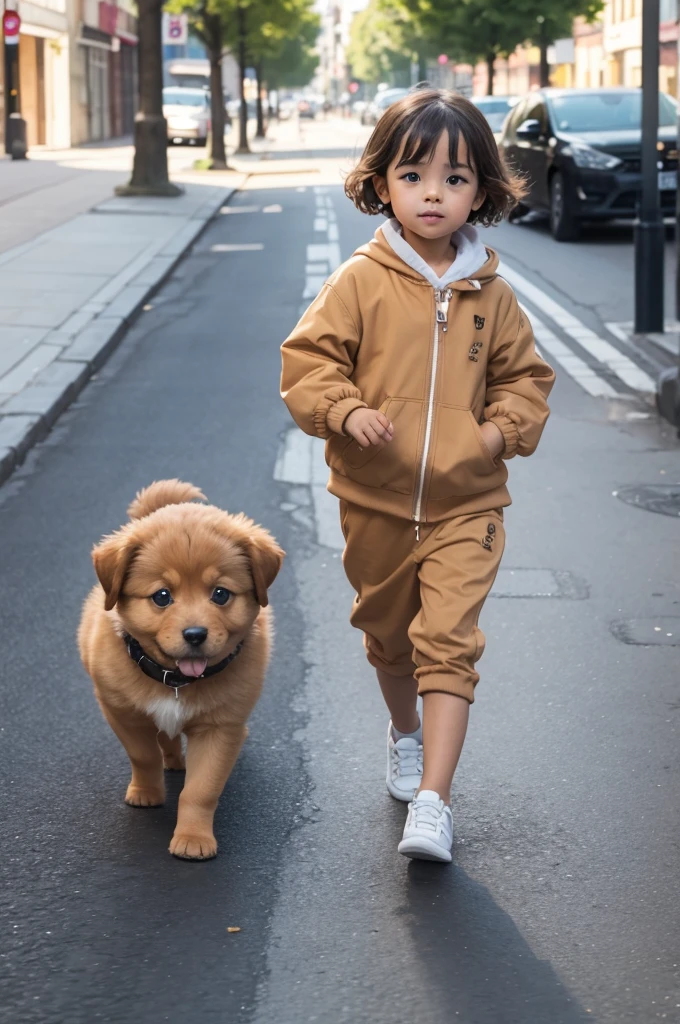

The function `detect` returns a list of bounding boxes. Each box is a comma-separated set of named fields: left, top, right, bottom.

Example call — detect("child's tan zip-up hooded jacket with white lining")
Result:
left=282, top=220, right=555, bottom=522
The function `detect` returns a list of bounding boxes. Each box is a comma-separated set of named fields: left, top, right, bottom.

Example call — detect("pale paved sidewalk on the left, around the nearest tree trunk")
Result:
left=0, top=145, right=251, bottom=483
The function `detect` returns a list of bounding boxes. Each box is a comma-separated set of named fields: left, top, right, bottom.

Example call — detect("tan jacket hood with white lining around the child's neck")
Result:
left=354, top=219, right=499, bottom=290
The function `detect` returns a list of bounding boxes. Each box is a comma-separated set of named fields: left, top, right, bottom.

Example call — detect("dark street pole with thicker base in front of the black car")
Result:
left=634, top=0, right=664, bottom=334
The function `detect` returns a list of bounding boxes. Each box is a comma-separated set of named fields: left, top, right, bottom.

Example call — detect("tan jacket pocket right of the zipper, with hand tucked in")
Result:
left=429, top=406, right=506, bottom=501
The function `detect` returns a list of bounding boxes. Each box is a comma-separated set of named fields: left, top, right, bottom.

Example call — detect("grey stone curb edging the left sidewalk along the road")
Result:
left=0, top=175, right=242, bottom=485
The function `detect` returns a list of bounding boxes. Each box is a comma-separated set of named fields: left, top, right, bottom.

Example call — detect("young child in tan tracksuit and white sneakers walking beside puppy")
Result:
left=282, top=89, right=554, bottom=861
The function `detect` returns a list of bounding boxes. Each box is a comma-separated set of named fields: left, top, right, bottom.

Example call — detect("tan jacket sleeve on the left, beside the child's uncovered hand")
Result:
left=281, top=284, right=366, bottom=437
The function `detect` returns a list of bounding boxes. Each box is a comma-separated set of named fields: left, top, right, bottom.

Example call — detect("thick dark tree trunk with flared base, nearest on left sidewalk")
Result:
left=116, top=0, right=182, bottom=196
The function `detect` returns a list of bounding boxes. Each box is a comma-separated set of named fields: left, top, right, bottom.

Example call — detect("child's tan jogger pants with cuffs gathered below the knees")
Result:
left=340, top=502, right=505, bottom=703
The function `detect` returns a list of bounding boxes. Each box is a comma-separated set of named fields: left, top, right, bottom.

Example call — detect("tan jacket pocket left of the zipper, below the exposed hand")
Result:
left=341, top=398, right=423, bottom=495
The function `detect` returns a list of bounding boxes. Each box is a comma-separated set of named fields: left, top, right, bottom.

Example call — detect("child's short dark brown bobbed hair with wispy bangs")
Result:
left=345, top=89, right=526, bottom=227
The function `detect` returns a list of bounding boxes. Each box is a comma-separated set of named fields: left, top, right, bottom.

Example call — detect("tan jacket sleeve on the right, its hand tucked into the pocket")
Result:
left=484, top=295, right=555, bottom=459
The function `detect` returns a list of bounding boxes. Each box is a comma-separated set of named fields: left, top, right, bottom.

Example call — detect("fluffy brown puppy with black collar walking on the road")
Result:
left=78, top=480, right=284, bottom=860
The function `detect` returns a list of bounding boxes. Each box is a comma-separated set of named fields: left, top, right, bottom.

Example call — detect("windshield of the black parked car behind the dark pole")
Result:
left=548, top=89, right=677, bottom=132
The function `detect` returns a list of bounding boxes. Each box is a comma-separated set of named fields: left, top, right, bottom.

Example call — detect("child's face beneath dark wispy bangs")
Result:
left=373, top=132, right=485, bottom=241
